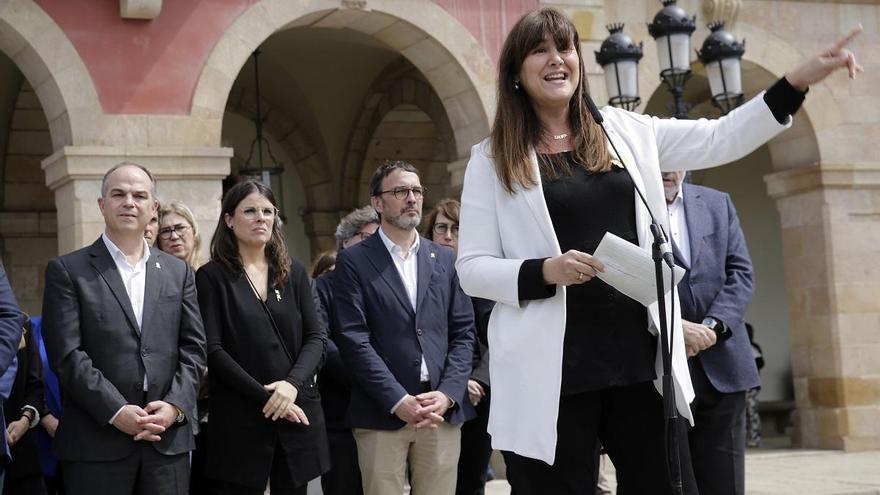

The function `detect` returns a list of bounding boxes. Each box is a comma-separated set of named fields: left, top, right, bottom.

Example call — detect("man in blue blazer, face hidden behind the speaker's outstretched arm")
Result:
left=663, top=172, right=760, bottom=495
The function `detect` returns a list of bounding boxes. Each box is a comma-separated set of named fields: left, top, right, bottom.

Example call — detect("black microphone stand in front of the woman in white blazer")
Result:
left=583, top=92, right=683, bottom=495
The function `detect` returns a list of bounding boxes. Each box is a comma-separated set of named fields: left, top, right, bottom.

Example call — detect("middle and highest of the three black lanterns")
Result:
left=648, top=0, right=697, bottom=118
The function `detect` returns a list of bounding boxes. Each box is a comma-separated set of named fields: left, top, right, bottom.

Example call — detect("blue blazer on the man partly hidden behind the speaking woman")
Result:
left=675, top=184, right=761, bottom=393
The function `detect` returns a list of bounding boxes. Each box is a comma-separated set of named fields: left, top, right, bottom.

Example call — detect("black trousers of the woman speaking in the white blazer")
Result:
left=503, top=382, right=697, bottom=495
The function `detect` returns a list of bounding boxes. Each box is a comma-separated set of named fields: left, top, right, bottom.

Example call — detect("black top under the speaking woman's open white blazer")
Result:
left=541, top=159, right=657, bottom=395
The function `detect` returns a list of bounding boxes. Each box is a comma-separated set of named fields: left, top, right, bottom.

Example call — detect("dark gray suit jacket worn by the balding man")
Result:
left=43, top=238, right=205, bottom=461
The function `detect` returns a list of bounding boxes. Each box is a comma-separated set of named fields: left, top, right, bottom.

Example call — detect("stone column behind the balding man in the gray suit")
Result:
left=43, top=146, right=232, bottom=259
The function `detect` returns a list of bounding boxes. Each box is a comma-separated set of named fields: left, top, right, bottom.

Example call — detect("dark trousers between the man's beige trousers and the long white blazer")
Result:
left=455, top=389, right=492, bottom=495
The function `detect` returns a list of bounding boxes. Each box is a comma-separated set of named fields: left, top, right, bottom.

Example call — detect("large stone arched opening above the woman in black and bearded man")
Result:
left=206, top=0, right=493, bottom=259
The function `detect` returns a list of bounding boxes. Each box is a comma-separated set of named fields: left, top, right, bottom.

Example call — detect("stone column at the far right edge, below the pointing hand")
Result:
left=765, top=164, right=880, bottom=450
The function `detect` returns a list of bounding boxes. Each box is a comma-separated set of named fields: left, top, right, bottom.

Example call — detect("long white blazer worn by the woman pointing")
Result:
left=456, top=93, right=791, bottom=465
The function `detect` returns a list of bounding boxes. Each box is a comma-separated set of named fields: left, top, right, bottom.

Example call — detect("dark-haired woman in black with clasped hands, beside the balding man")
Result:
left=196, top=181, right=329, bottom=495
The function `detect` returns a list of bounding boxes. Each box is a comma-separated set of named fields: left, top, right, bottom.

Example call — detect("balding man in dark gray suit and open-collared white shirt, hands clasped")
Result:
left=43, top=163, right=205, bottom=495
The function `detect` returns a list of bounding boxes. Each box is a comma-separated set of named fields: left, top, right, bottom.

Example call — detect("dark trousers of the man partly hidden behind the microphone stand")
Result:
left=688, top=358, right=746, bottom=495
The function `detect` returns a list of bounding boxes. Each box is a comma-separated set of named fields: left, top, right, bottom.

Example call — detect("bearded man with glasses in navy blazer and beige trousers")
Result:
left=335, top=161, right=474, bottom=495
